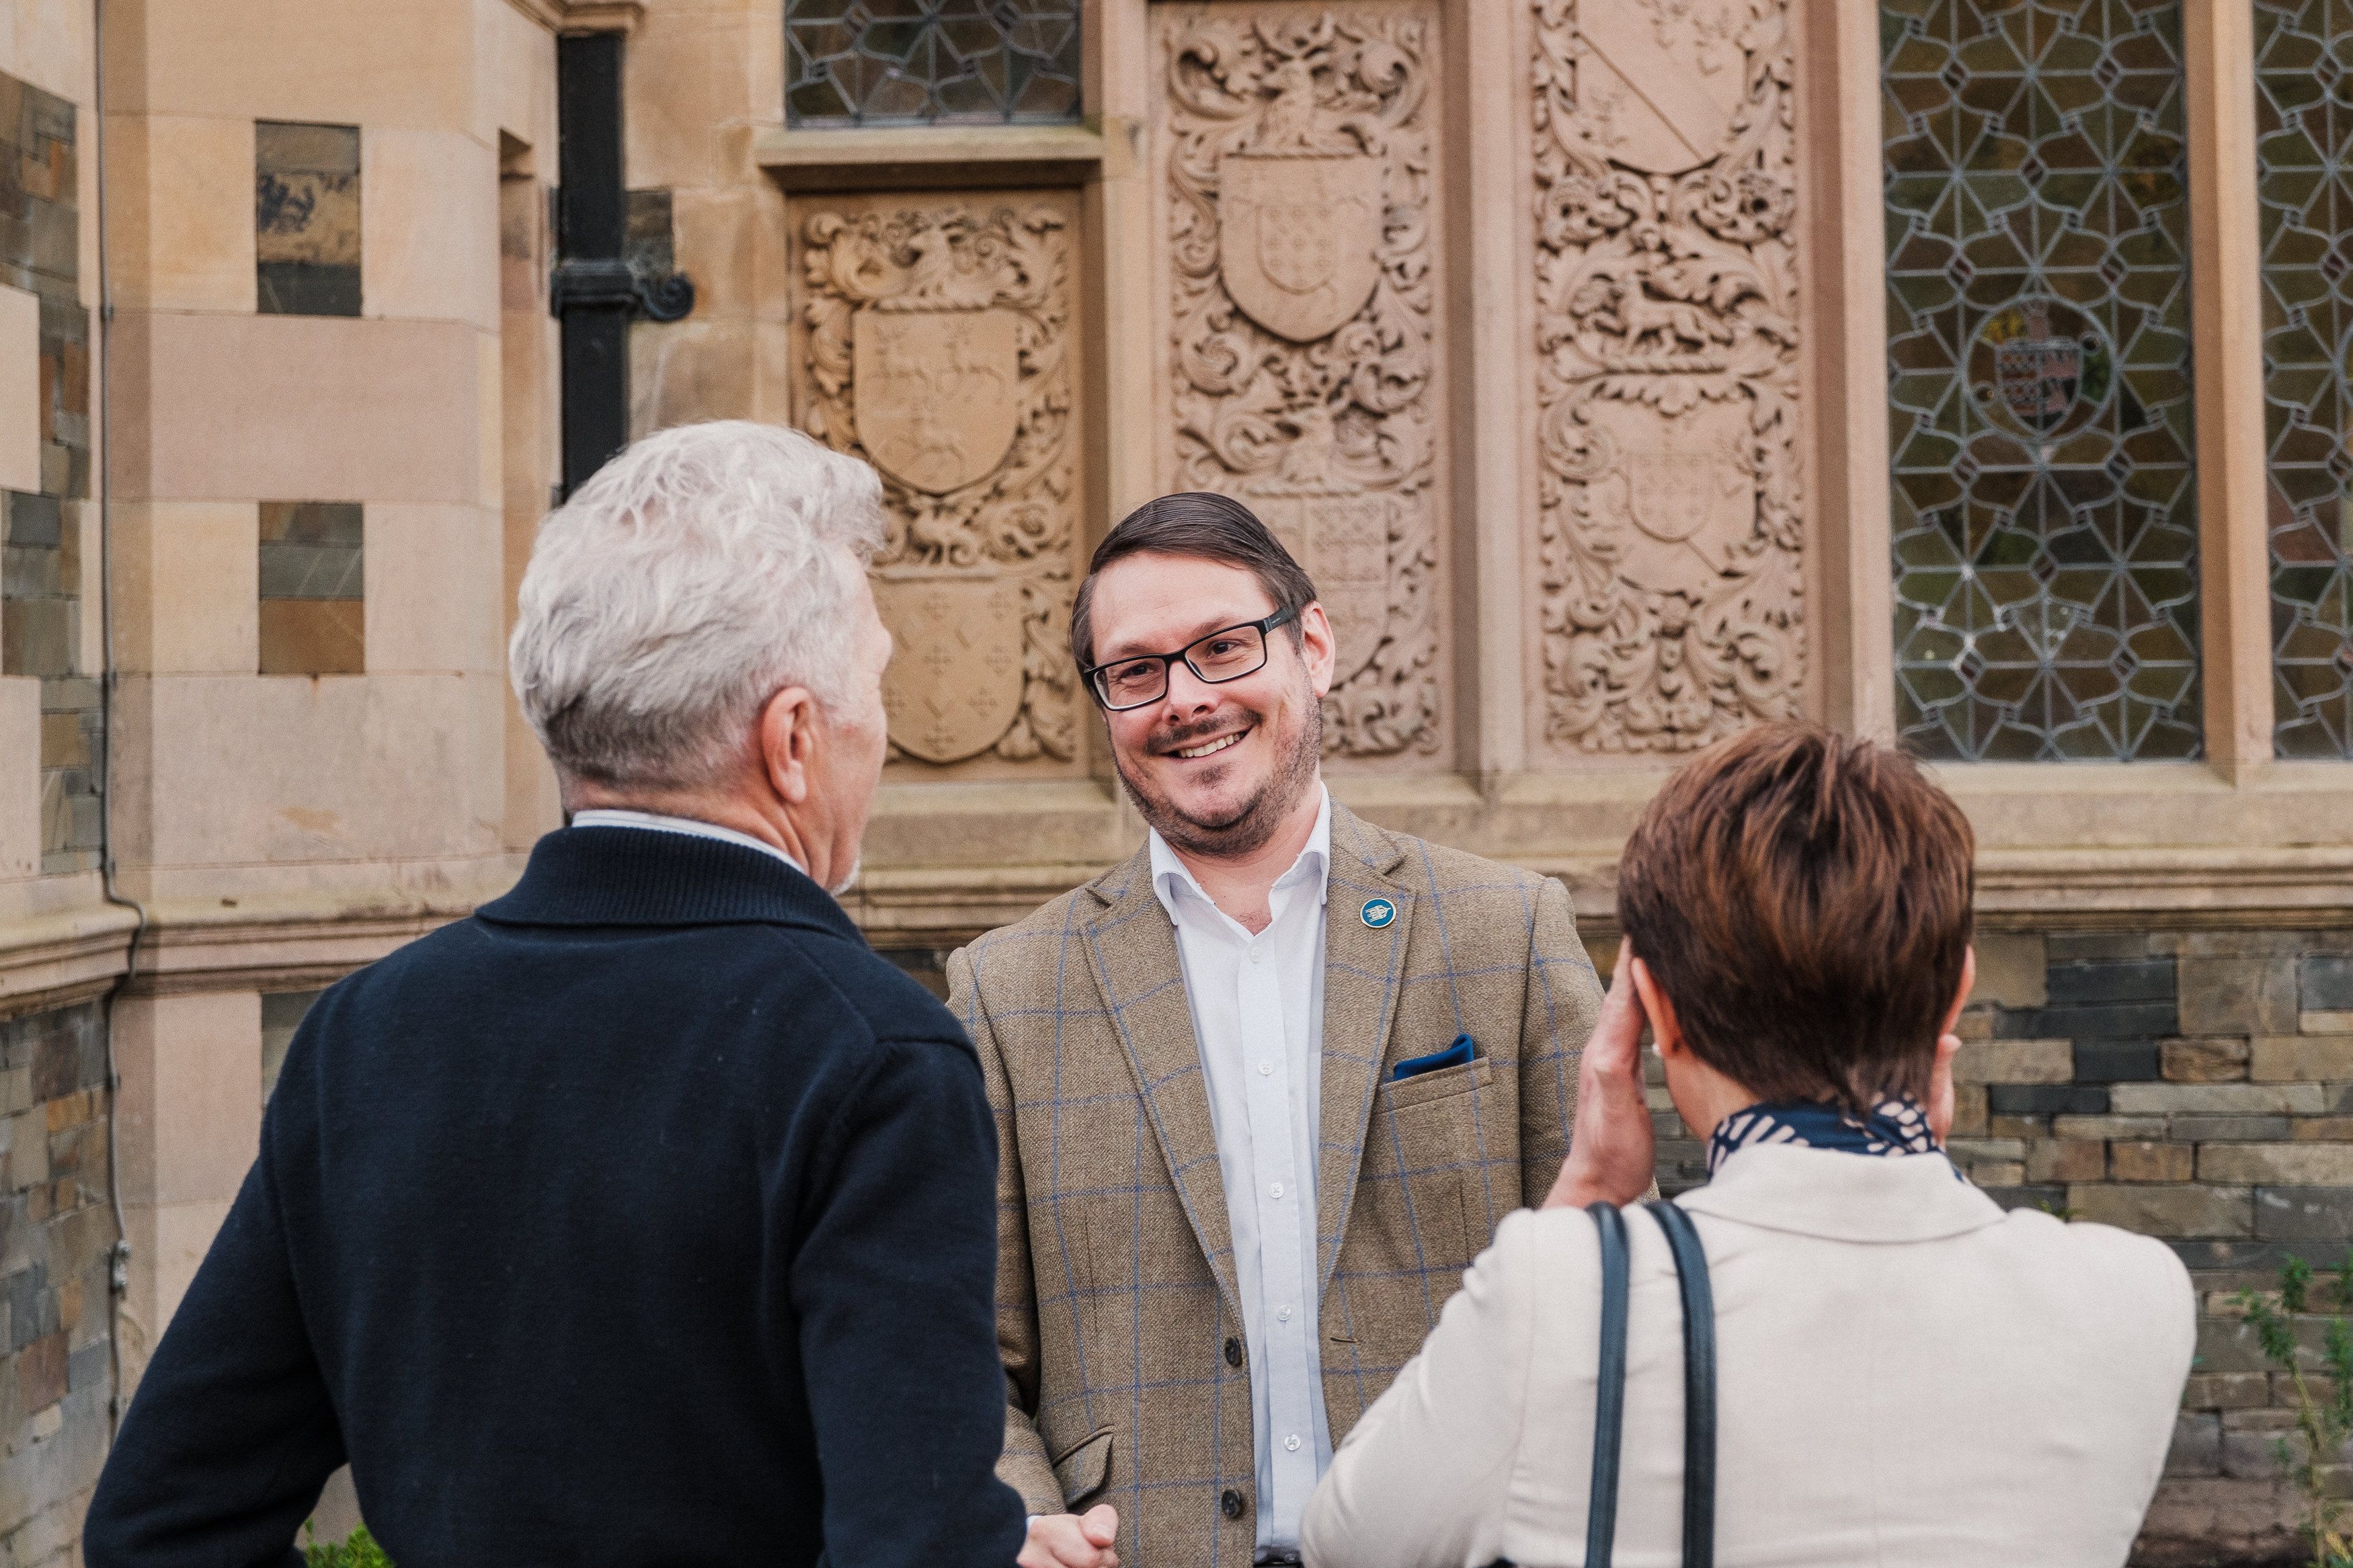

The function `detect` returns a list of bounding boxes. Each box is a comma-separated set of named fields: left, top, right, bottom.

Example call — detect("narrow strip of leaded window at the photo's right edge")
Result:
left=2254, top=0, right=2353, bottom=757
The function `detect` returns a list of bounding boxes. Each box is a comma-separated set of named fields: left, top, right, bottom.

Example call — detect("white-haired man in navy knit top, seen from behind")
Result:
left=83, top=423, right=1024, bottom=1568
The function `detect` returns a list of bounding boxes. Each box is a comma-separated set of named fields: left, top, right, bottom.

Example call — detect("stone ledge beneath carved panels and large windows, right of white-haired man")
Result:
left=847, top=761, right=2353, bottom=945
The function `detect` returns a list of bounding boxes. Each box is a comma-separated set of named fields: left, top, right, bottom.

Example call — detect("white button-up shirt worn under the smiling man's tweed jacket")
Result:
left=1151, top=792, right=1332, bottom=1557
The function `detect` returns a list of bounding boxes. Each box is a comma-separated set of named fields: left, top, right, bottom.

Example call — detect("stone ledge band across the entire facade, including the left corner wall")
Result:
left=0, top=761, right=2353, bottom=1011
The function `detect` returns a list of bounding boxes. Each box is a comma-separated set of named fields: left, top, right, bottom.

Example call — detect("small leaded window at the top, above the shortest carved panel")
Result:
left=784, top=0, right=1080, bottom=124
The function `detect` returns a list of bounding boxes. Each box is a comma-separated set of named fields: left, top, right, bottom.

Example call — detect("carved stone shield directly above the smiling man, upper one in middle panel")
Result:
left=1217, top=155, right=1382, bottom=343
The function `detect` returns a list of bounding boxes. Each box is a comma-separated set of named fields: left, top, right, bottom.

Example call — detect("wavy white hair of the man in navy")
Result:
left=506, top=419, right=883, bottom=790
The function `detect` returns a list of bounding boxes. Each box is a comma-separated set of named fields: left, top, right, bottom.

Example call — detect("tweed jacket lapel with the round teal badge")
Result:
left=1316, top=802, right=1402, bottom=1293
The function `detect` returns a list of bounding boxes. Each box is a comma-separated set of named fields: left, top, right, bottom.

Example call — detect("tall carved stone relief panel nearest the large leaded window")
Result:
left=1532, top=0, right=1805, bottom=752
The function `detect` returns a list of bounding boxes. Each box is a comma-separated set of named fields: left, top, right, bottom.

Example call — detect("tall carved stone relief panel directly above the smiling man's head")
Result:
left=1160, top=2, right=1443, bottom=757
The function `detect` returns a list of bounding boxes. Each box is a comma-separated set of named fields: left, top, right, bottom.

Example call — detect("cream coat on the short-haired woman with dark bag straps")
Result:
left=1304, top=1147, right=2196, bottom=1568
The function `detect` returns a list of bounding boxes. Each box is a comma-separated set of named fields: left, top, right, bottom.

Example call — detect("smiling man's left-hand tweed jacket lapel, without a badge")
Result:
left=1085, top=849, right=1242, bottom=1321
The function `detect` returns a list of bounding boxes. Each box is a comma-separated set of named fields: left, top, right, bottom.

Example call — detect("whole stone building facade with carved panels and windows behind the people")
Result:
left=0, top=0, right=2353, bottom=1563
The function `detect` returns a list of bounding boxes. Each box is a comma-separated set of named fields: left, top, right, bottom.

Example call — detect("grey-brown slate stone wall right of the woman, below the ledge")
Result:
left=1951, top=931, right=2353, bottom=1568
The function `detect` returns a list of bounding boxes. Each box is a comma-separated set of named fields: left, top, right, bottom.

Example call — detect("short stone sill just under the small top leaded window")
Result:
left=753, top=118, right=1137, bottom=190
